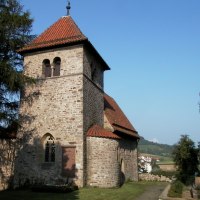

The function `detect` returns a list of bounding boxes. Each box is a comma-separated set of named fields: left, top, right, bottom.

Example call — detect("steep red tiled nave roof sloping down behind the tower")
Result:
left=104, top=94, right=139, bottom=138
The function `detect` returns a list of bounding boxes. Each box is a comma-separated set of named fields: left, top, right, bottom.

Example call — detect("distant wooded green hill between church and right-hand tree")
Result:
left=138, top=137, right=173, bottom=158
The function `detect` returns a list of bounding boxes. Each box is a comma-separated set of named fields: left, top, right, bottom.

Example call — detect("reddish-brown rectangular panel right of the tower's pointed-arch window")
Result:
left=62, top=147, right=76, bottom=178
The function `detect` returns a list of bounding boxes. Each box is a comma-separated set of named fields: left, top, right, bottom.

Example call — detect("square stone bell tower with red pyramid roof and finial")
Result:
left=15, top=7, right=109, bottom=186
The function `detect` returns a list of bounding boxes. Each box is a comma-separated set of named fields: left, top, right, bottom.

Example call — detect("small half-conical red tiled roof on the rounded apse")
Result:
left=87, top=125, right=121, bottom=139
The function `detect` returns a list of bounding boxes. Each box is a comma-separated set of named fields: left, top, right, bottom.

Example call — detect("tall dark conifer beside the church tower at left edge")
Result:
left=0, top=0, right=34, bottom=138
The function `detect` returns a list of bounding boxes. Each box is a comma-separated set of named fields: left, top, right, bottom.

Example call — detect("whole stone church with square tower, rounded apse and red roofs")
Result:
left=1, top=10, right=139, bottom=187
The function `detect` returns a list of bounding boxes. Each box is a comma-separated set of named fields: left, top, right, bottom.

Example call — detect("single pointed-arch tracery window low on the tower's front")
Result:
left=43, top=133, right=56, bottom=162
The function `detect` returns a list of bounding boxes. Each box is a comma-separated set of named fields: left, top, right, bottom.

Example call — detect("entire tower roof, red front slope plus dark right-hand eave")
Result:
left=18, top=16, right=110, bottom=70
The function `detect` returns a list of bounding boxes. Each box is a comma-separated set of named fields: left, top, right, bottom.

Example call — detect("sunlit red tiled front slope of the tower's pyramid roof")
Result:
left=19, top=16, right=87, bottom=53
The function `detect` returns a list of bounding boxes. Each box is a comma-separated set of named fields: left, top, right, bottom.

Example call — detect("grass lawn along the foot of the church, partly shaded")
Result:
left=0, top=182, right=164, bottom=200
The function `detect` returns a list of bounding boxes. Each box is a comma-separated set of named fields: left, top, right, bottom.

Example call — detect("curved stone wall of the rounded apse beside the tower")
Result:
left=87, top=137, right=120, bottom=188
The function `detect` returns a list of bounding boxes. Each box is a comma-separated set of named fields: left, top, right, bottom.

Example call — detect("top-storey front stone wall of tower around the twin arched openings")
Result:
left=24, top=45, right=83, bottom=78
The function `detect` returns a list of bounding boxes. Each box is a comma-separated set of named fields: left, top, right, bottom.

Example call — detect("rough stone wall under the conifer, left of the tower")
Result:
left=0, top=139, right=18, bottom=191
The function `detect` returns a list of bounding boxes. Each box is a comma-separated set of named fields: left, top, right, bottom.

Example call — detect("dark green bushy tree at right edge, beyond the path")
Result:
left=172, top=135, right=199, bottom=184
